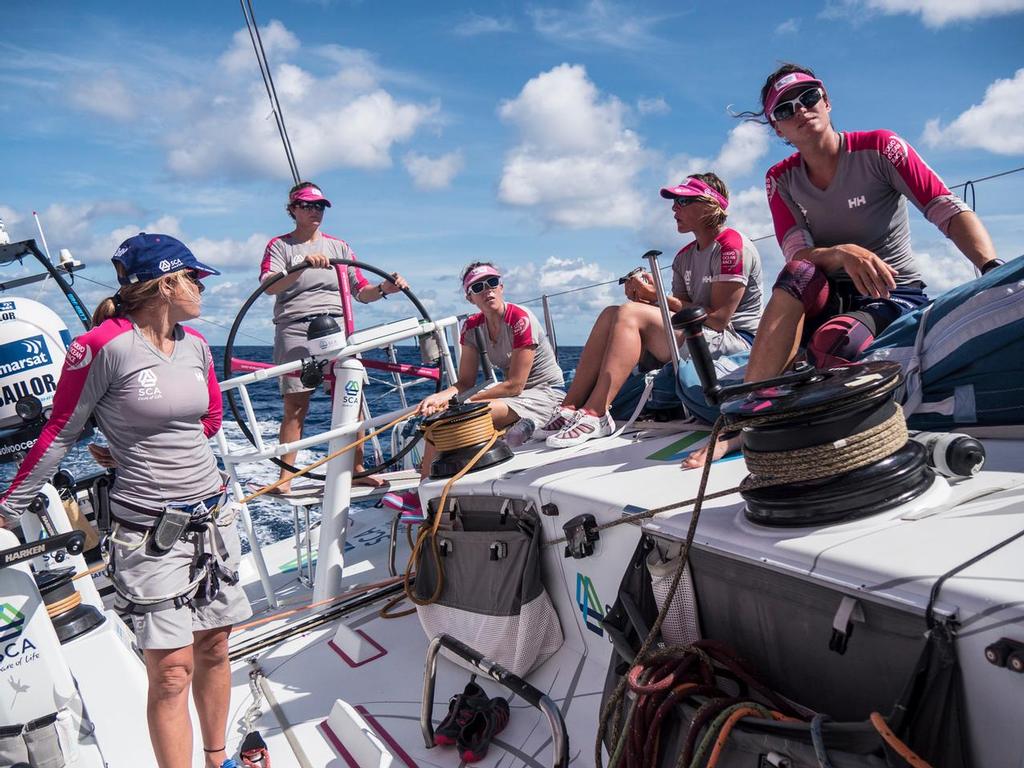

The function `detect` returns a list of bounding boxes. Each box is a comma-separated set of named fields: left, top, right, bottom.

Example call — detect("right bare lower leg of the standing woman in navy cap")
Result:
left=193, top=627, right=231, bottom=768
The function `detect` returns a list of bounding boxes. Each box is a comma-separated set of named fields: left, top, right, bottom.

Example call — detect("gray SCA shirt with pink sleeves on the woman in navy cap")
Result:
left=0, top=317, right=222, bottom=516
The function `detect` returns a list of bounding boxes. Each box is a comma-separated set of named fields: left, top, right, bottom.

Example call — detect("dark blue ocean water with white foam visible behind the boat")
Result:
left=0, top=346, right=582, bottom=544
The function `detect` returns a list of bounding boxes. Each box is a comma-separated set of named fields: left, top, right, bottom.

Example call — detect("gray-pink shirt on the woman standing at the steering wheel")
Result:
left=259, top=232, right=370, bottom=325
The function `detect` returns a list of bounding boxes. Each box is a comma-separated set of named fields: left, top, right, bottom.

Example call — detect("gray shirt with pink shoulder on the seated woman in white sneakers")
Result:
left=672, top=229, right=763, bottom=334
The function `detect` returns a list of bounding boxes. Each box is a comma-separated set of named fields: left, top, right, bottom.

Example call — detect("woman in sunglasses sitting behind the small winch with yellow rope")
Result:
left=383, top=261, right=565, bottom=515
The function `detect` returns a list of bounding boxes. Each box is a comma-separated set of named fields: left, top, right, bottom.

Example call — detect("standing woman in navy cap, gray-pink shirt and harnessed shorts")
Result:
left=0, top=232, right=252, bottom=768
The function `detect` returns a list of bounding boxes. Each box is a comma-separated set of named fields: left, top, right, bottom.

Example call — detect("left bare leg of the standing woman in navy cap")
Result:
left=143, top=645, right=194, bottom=768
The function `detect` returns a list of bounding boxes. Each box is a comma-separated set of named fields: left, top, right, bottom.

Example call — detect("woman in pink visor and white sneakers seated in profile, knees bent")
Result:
left=535, top=173, right=761, bottom=447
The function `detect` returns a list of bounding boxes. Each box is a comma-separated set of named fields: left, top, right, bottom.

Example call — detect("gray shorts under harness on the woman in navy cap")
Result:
left=111, top=499, right=252, bottom=649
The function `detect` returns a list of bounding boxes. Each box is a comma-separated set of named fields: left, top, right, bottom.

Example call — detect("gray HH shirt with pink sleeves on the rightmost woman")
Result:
left=765, top=130, right=971, bottom=286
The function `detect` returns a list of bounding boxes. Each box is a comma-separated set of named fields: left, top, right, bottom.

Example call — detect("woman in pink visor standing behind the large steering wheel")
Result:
left=260, top=181, right=409, bottom=494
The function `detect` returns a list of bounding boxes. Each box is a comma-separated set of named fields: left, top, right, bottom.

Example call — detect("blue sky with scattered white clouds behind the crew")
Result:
left=0, top=0, right=1024, bottom=344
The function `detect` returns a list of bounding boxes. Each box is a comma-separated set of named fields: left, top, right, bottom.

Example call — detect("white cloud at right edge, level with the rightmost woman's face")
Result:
left=924, top=69, right=1024, bottom=155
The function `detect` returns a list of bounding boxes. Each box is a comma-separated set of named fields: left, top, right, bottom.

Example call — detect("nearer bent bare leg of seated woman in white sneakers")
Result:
left=583, top=302, right=671, bottom=416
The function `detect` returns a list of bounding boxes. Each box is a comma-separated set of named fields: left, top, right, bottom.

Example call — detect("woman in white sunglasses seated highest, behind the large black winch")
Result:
left=688, top=63, right=1002, bottom=466
